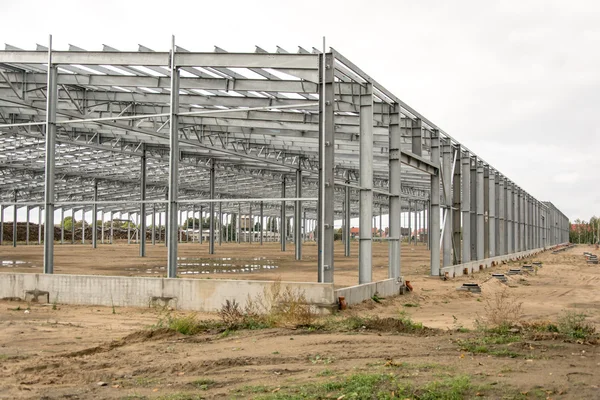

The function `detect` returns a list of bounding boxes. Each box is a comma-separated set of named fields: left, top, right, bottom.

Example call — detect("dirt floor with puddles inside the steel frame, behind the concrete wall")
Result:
left=0, top=241, right=429, bottom=287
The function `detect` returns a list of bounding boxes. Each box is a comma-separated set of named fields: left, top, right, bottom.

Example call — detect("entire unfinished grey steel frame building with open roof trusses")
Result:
left=0, top=38, right=569, bottom=283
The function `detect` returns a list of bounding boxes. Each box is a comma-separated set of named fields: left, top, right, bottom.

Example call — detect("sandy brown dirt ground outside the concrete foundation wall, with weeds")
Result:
left=0, top=244, right=600, bottom=400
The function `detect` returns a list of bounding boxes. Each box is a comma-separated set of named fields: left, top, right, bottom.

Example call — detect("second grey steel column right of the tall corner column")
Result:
left=388, top=103, right=402, bottom=278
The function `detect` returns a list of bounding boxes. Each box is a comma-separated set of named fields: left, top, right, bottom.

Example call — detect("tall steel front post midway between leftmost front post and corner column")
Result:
left=167, top=37, right=180, bottom=278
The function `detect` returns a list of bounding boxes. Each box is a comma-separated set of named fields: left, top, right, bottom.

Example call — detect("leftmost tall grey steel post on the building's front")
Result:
left=42, top=36, right=58, bottom=274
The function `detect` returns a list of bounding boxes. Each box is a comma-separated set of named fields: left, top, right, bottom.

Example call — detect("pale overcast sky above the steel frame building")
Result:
left=0, top=0, right=600, bottom=220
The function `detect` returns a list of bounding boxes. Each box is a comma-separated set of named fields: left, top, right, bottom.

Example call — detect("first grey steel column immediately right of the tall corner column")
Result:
left=358, top=83, right=373, bottom=284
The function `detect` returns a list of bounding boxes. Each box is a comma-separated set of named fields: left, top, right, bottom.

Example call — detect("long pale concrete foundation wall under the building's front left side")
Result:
left=0, top=273, right=337, bottom=311
